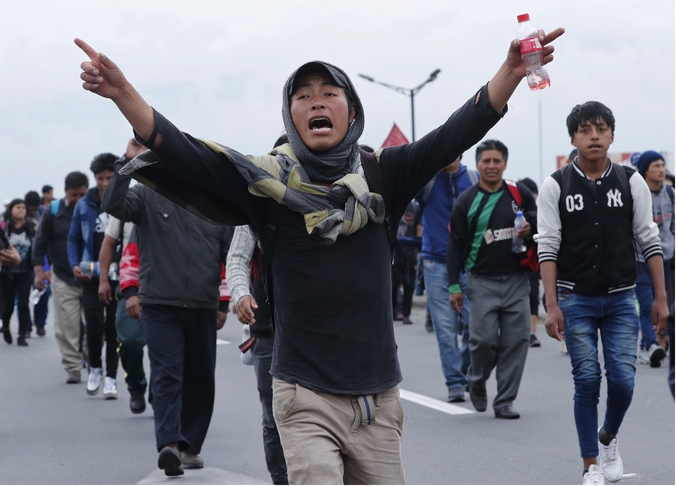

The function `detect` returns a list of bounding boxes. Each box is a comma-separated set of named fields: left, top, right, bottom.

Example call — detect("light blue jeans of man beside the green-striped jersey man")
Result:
left=423, top=260, right=470, bottom=388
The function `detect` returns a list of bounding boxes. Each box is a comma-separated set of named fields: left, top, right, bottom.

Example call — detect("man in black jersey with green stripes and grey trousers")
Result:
left=448, top=140, right=537, bottom=419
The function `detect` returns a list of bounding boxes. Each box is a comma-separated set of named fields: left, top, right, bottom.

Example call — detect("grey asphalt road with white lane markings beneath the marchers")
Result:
left=0, top=298, right=674, bottom=485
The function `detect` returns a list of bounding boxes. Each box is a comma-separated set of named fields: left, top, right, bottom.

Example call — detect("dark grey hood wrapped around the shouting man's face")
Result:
left=282, top=61, right=364, bottom=182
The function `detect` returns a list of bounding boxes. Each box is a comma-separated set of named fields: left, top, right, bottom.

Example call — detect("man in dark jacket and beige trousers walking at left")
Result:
left=32, top=172, right=89, bottom=383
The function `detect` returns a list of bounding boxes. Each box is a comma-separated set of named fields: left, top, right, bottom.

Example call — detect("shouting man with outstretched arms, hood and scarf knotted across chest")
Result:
left=76, top=29, right=563, bottom=484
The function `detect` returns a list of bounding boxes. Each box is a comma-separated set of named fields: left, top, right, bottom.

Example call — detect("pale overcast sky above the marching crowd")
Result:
left=0, top=0, right=674, bottom=200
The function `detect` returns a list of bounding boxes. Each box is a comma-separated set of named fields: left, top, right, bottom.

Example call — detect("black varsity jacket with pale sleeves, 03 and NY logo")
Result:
left=535, top=161, right=662, bottom=295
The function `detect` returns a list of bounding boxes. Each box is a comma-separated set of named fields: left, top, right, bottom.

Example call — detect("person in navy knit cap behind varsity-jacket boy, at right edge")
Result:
left=636, top=150, right=674, bottom=368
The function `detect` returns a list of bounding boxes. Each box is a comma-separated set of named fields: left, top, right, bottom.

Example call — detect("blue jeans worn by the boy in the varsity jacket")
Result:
left=559, top=288, right=639, bottom=458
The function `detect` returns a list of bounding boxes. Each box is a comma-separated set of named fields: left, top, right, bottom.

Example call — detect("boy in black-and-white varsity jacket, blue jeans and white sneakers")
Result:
left=536, top=101, right=668, bottom=484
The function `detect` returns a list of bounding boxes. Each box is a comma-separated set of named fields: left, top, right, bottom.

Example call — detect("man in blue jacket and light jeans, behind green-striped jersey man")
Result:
left=418, top=155, right=479, bottom=402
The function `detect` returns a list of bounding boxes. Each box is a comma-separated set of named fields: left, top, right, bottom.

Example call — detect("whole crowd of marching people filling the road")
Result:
left=0, top=22, right=674, bottom=484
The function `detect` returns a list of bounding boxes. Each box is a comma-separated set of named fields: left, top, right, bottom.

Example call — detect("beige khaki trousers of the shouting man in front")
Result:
left=272, top=378, right=404, bottom=484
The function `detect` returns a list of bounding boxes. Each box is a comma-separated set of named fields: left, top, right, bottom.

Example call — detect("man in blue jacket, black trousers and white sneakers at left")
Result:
left=68, top=153, right=119, bottom=399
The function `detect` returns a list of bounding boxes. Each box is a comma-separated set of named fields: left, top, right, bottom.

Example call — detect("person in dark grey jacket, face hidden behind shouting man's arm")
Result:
left=102, top=141, right=232, bottom=476
